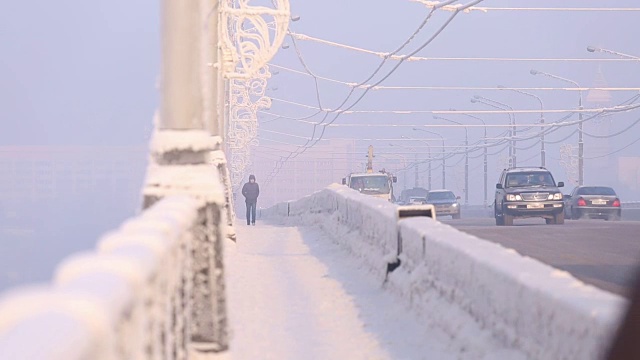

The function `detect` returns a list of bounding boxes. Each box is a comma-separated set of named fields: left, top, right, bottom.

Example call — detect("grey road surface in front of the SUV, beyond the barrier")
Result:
left=441, top=218, right=640, bottom=296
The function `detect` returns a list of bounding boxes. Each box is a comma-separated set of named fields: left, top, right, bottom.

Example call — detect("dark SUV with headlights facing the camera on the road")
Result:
left=493, top=167, right=564, bottom=226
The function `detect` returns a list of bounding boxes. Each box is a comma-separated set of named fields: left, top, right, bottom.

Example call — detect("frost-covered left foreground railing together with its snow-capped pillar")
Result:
left=0, top=131, right=231, bottom=360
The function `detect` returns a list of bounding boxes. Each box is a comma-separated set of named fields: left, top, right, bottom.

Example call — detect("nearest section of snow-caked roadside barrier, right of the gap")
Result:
left=391, top=219, right=626, bottom=359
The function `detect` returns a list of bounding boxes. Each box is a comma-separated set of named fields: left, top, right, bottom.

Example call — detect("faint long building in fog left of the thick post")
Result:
left=0, top=146, right=148, bottom=203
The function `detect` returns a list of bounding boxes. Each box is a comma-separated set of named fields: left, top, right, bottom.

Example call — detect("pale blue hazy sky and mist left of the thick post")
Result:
left=0, top=0, right=160, bottom=290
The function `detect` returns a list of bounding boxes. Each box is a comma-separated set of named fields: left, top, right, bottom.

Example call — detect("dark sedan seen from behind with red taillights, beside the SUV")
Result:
left=564, top=186, right=622, bottom=220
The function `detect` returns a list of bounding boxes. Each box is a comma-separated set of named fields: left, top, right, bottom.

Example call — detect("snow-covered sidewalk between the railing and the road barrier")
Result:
left=225, top=222, right=471, bottom=359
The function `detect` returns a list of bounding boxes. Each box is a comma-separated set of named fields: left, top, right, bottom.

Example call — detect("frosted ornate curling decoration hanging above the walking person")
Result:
left=220, top=0, right=290, bottom=188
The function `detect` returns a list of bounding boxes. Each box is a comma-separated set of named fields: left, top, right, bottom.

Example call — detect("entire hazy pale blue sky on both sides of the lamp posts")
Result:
left=0, top=0, right=640, bottom=290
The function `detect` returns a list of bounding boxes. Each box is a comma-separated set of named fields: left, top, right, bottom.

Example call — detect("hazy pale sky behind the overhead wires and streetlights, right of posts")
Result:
left=252, top=0, right=640, bottom=204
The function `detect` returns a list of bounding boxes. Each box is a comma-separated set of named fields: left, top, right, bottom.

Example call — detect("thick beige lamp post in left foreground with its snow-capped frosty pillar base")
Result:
left=143, top=0, right=235, bottom=353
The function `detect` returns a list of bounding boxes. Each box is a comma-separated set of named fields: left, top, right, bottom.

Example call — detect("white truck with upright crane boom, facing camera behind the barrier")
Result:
left=342, top=146, right=398, bottom=202
